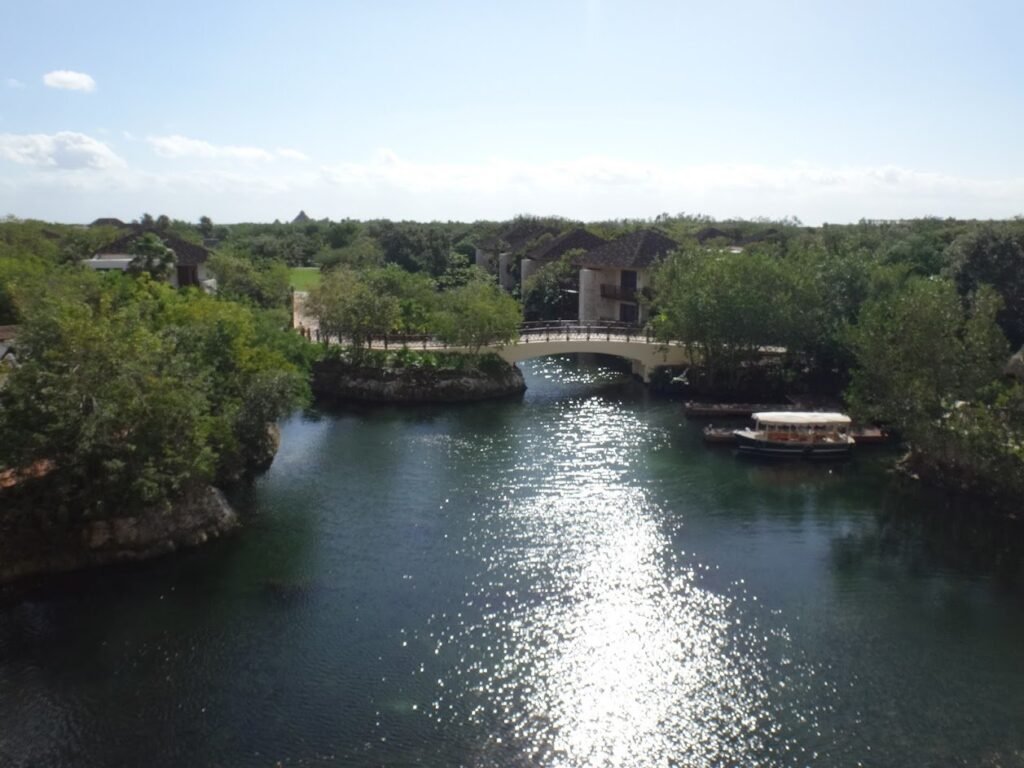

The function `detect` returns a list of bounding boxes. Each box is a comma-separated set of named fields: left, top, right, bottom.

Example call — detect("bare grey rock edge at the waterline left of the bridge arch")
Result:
left=311, top=359, right=526, bottom=403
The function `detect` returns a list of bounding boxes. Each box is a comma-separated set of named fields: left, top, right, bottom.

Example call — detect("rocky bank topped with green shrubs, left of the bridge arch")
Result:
left=310, top=350, right=526, bottom=403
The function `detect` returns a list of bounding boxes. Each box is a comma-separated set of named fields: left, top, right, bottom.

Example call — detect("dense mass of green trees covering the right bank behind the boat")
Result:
left=653, top=220, right=1024, bottom=499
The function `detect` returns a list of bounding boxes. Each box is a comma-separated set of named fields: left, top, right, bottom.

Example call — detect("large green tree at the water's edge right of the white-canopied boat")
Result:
left=847, top=279, right=1024, bottom=499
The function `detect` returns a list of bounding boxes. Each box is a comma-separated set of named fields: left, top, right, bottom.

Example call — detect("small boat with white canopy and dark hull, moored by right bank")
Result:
left=733, top=411, right=854, bottom=459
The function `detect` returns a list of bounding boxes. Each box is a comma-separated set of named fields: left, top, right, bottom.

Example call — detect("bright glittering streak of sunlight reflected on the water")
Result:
left=403, top=370, right=827, bottom=766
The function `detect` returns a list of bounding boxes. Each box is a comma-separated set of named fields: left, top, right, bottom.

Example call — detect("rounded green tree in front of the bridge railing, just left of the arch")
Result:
left=434, top=282, right=522, bottom=353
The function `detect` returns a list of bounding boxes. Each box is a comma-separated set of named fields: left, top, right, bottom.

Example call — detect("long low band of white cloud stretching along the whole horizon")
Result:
left=0, top=147, right=1024, bottom=224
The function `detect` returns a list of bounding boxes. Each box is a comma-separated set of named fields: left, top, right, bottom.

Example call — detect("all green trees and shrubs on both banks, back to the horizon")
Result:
left=0, top=210, right=1024, bottom=573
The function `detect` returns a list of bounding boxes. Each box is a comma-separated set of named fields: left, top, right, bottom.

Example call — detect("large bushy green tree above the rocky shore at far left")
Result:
left=0, top=280, right=216, bottom=516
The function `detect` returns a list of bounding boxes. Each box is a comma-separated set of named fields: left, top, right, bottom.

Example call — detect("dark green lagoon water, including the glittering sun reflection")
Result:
left=0, top=358, right=1024, bottom=768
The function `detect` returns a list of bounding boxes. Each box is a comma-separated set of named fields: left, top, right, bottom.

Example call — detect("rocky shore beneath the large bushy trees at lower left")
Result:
left=0, top=485, right=239, bottom=585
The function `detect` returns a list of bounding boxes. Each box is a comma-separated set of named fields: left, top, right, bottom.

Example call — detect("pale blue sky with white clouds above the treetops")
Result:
left=0, top=0, right=1024, bottom=224
